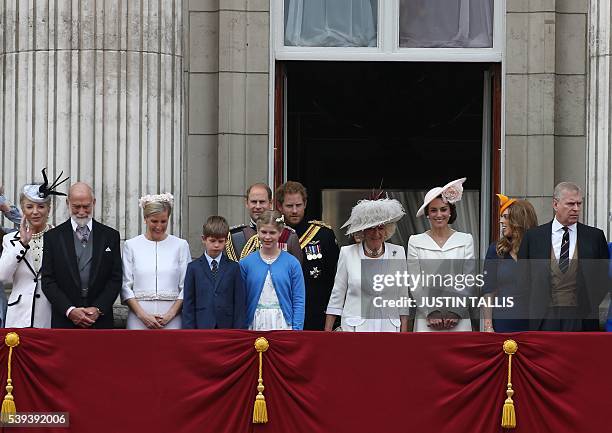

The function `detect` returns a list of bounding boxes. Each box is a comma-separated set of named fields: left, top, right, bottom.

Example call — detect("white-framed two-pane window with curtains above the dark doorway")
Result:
left=271, top=0, right=506, bottom=62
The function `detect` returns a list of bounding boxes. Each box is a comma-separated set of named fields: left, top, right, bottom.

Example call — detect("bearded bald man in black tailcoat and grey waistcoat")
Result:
left=41, top=182, right=122, bottom=329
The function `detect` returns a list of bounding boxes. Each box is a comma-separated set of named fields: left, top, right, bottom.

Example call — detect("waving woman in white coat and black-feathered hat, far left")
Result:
left=0, top=169, right=68, bottom=328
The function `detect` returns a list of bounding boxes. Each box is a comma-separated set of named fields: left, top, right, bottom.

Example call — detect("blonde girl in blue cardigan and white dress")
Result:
left=240, top=210, right=305, bottom=331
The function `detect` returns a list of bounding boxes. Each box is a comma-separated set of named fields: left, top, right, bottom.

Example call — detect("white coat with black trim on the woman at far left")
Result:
left=0, top=226, right=51, bottom=328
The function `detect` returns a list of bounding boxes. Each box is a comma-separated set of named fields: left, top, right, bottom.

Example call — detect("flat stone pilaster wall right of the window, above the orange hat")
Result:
left=505, top=0, right=588, bottom=223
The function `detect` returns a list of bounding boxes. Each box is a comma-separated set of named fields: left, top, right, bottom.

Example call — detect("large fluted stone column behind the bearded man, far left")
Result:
left=0, top=0, right=183, bottom=238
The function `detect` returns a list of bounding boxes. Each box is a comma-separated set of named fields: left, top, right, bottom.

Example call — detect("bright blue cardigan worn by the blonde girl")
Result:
left=240, top=251, right=306, bottom=330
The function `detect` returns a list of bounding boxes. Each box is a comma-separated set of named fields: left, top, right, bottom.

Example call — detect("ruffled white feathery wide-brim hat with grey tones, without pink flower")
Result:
left=340, top=198, right=406, bottom=235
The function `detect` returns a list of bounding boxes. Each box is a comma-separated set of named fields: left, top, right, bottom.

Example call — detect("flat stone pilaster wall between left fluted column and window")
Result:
left=185, top=0, right=271, bottom=255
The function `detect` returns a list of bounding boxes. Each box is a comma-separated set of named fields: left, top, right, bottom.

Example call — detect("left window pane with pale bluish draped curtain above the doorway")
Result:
left=285, top=0, right=378, bottom=47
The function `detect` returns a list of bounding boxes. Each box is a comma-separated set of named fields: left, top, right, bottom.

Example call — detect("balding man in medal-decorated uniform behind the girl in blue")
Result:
left=225, top=183, right=302, bottom=263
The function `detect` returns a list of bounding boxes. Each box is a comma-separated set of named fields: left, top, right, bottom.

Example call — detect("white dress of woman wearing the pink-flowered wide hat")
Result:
left=408, top=232, right=476, bottom=332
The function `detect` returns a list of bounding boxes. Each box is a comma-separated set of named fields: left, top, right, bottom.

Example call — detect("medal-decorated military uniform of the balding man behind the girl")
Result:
left=225, top=221, right=302, bottom=263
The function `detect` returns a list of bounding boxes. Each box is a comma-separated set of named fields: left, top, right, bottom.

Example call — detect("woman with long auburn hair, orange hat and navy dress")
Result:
left=482, top=194, right=538, bottom=332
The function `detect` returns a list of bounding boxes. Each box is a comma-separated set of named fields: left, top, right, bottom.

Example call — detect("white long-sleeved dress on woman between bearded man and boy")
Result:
left=121, top=235, right=191, bottom=329
